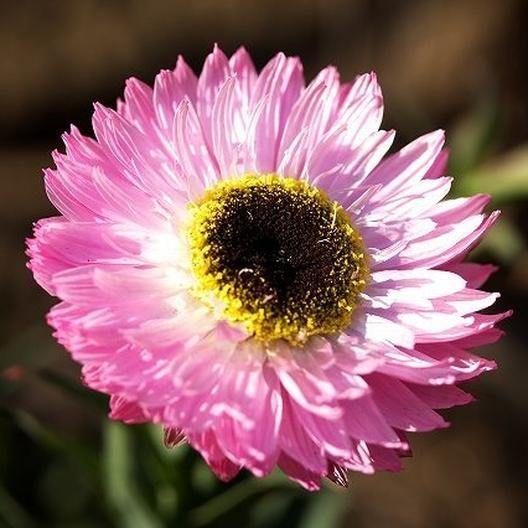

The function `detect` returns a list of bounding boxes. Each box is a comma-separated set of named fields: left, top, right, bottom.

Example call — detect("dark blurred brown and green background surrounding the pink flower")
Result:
left=0, top=0, right=528, bottom=528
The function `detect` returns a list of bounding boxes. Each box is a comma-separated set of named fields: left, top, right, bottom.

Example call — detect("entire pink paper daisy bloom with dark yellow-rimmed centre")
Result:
left=28, top=47, right=507, bottom=489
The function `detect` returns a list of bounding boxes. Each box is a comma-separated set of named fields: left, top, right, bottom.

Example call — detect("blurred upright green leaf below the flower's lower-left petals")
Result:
left=104, top=422, right=163, bottom=528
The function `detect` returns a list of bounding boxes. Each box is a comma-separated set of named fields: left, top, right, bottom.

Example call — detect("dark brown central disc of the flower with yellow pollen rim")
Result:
left=189, top=174, right=368, bottom=344
